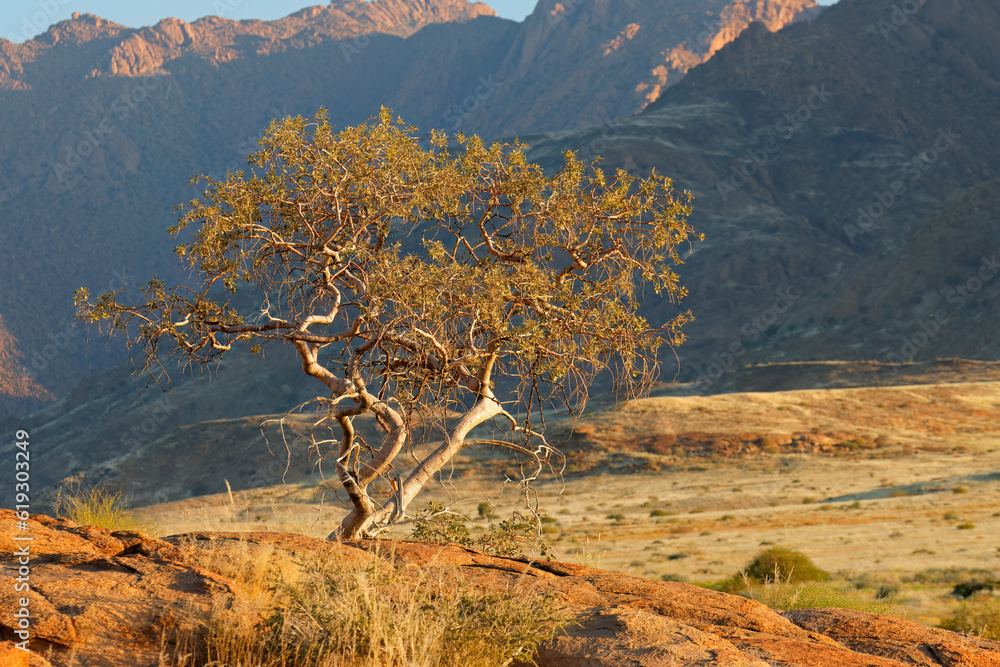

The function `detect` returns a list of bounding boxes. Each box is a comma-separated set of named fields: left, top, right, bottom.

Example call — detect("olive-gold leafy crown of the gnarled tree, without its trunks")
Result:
left=76, top=104, right=694, bottom=396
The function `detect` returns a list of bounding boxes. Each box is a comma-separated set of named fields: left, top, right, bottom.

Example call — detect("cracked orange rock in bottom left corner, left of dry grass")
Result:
left=0, top=510, right=232, bottom=667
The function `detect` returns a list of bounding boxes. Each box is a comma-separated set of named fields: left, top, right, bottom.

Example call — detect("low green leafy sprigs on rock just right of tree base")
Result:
left=410, top=502, right=555, bottom=560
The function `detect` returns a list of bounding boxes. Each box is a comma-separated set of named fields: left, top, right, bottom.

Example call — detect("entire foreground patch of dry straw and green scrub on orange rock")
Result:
left=161, top=538, right=568, bottom=667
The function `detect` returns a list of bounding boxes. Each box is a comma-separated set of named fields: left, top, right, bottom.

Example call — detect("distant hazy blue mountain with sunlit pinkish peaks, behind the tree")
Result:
left=0, top=0, right=817, bottom=415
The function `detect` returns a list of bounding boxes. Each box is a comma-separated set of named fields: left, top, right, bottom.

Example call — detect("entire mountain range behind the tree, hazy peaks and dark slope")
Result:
left=0, top=0, right=1000, bottom=501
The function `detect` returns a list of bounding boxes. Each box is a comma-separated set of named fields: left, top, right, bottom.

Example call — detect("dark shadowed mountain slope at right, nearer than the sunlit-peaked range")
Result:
left=528, top=0, right=1000, bottom=390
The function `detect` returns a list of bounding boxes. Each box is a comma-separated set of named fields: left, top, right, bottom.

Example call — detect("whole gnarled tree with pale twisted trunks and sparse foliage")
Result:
left=76, top=109, right=694, bottom=538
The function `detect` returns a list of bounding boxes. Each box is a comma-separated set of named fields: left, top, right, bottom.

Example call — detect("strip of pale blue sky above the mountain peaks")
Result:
left=0, top=0, right=835, bottom=42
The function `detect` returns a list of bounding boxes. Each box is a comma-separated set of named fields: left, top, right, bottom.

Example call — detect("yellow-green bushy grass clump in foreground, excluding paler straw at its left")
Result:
left=264, top=563, right=568, bottom=667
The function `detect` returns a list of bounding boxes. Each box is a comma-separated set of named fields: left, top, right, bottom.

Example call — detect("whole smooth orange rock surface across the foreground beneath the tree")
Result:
left=0, top=510, right=1000, bottom=667
